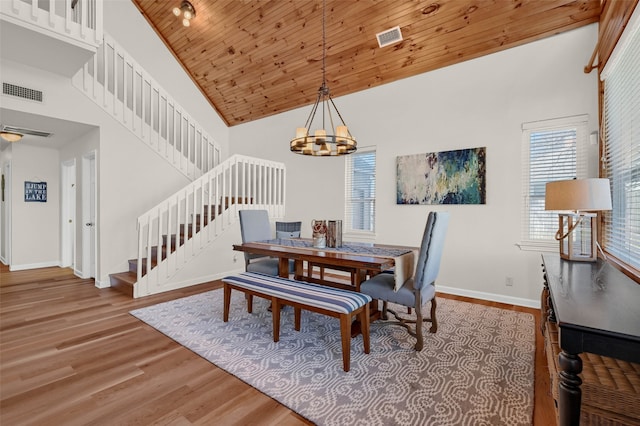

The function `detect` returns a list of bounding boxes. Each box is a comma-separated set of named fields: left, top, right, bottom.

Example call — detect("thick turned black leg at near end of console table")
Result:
left=558, top=351, right=582, bottom=426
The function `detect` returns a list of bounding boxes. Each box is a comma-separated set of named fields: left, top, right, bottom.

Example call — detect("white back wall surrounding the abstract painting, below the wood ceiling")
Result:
left=230, top=24, right=598, bottom=306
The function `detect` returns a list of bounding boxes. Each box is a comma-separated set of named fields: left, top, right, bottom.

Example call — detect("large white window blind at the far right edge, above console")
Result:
left=602, top=11, right=640, bottom=269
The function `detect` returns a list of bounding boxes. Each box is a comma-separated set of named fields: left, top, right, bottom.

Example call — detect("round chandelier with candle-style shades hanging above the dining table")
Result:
left=290, top=1, right=357, bottom=157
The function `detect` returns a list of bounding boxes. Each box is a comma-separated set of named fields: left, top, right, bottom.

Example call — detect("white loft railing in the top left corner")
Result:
left=0, top=0, right=103, bottom=46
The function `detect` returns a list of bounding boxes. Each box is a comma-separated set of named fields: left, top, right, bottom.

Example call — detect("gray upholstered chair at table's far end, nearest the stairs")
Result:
left=238, top=210, right=295, bottom=275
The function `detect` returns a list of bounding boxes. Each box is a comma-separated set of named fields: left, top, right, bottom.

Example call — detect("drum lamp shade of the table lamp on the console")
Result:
left=544, top=178, right=611, bottom=211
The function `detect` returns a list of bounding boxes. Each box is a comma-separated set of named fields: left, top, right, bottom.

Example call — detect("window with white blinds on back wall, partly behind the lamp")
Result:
left=520, top=115, right=588, bottom=251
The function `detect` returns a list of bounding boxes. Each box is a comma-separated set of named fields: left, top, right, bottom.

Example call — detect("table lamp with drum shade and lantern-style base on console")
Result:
left=544, top=178, right=611, bottom=262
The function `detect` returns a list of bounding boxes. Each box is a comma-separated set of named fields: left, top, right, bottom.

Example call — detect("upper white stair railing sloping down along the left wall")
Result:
left=73, top=33, right=221, bottom=180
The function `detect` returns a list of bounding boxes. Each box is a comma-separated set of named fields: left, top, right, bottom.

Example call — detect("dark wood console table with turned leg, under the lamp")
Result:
left=542, top=254, right=640, bottom=426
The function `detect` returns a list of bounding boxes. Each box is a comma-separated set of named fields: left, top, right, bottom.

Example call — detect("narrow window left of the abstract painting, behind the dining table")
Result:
left=345, top=148, right=376, bottom=235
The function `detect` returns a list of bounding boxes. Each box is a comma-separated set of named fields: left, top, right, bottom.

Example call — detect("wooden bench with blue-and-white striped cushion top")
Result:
left=222, top=272, right=372, bottom=371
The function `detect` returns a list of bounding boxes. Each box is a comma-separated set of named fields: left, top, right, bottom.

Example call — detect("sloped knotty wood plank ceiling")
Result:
left=133, top=0, right=600, bottom=126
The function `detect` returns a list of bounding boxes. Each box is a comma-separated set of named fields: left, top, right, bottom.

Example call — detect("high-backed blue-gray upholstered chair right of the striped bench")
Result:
left=360, top=212, right=449, bottom=351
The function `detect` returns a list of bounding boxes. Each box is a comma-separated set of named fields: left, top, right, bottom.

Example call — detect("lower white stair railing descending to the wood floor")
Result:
left=133, top=155, right=285, bottom=297
